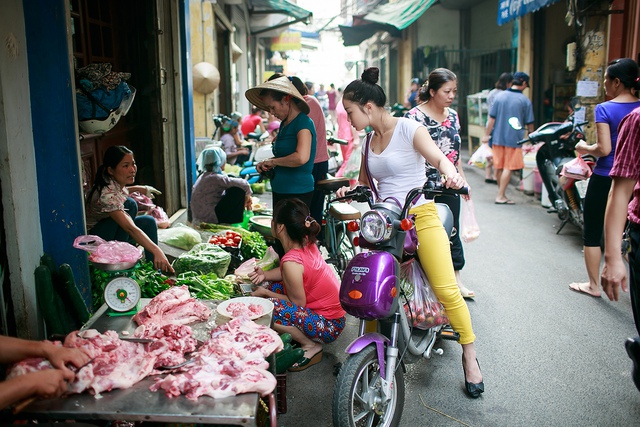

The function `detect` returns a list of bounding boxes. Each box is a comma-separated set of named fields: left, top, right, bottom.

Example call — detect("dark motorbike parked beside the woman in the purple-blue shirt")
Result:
left=518, top=114, right=595, bottom=234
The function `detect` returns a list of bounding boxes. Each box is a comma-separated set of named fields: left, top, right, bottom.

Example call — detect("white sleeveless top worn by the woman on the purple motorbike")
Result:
left=369, top=117, right=427, bottom=206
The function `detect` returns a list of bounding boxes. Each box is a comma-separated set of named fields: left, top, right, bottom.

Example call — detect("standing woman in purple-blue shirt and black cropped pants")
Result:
left=569, top=58, right=640, bottom=298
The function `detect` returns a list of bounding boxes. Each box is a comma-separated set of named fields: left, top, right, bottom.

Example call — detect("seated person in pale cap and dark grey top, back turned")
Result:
left=191, top=147, right=251, bottom=224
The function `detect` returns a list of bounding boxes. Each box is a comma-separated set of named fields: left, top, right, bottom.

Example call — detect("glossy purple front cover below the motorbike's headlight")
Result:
left=340, top=251, right=400, bottom=320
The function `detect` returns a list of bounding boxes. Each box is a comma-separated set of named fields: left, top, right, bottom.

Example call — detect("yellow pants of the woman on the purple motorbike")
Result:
left=409, top=203, right=476, bottom=344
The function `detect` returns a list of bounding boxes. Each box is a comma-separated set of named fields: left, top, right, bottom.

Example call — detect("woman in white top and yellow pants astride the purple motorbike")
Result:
left=337, top=67, right=484, bottom=398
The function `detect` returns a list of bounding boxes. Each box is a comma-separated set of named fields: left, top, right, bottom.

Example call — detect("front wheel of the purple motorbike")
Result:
left=333, top=345, right=404, bottom=427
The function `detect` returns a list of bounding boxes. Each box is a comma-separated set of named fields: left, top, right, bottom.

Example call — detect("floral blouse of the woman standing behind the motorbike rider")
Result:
left=405, top=107, right=461, bottom=178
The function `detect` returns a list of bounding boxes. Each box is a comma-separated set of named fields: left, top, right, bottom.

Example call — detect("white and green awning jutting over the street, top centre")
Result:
left=339, top=0, right=436, bottom=46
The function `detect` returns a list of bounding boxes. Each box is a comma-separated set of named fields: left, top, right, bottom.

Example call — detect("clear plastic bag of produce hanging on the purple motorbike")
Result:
left=400, top=258, right=449, bottom=330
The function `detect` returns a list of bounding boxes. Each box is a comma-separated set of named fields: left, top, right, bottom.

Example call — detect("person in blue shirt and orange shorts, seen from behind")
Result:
left=482, top=71, right=533, bottom=205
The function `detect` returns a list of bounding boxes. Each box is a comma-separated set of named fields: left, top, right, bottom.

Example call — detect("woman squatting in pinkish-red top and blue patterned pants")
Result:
left=249, top=198, right=345, bottom=371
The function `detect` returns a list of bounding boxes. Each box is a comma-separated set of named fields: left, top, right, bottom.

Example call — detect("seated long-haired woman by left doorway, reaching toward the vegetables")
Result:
left=86, top=145, right=174, bottom=273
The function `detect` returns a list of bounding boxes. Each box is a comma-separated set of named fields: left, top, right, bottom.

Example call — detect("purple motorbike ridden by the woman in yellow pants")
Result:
left=333, top=181, right=468, bottom=427
